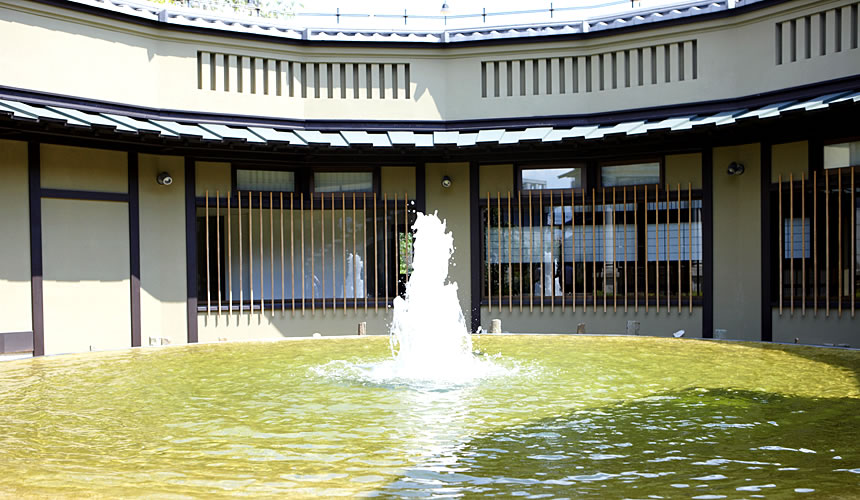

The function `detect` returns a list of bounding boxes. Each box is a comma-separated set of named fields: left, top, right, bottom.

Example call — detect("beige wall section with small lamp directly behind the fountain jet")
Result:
left=425, top=163, right=472, bottom=323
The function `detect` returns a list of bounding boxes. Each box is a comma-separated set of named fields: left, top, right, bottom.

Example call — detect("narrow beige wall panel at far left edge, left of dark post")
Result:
left=0, top=140, right=33, bottom=333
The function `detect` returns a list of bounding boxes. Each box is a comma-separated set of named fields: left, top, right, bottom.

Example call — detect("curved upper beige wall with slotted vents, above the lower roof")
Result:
left=0, top=0, right=860, bottom=120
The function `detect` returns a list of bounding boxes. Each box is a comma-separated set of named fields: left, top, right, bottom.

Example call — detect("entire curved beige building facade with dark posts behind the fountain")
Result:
left=0, top=0, right=860, bottom=355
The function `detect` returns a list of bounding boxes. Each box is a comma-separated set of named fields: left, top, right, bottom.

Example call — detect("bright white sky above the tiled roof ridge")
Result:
left=295, top=0, right=680, bottom=30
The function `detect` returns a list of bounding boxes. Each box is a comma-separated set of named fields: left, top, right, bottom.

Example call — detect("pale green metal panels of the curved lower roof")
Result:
left=0, top=89, right=860, bottom=149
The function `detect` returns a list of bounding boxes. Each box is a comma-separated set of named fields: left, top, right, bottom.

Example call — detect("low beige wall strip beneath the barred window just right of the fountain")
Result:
left=481, top=304, right=702, bottom=338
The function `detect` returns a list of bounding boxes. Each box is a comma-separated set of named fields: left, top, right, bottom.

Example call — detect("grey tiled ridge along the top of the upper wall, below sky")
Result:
left=57, top=0, right=765, bottom=44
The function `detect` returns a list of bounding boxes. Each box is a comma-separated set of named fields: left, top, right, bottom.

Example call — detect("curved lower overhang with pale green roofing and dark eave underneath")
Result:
left=0, top=81, right=860, bottom=160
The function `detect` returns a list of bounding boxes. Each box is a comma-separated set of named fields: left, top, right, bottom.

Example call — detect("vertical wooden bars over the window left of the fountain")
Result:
left=198, top=190, right=420, bottom=316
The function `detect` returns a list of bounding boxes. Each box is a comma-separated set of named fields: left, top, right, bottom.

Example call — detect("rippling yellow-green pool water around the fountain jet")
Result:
left=0, top=336, right=860, bottom=498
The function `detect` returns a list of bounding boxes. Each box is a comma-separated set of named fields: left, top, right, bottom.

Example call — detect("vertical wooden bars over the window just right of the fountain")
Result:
left=476, top=186, right=702, bottom=314
